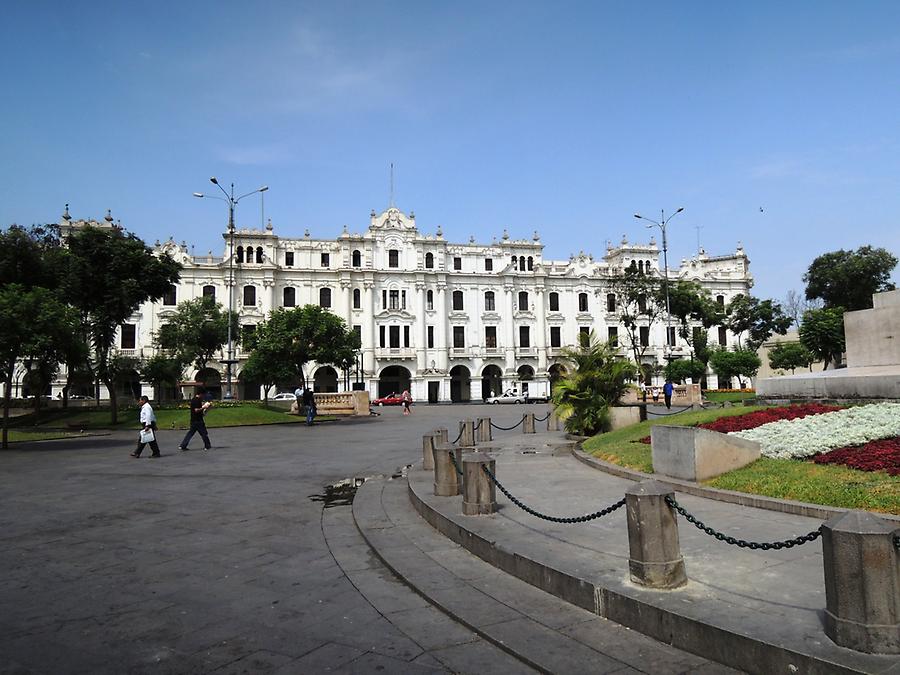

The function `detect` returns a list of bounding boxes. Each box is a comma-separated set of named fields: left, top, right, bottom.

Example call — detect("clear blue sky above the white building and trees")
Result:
left=0, top=0, right=900, bottom=299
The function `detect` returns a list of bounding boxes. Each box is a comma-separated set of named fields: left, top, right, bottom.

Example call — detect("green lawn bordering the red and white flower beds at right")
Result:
left=584, top=406, right=900, bottom=515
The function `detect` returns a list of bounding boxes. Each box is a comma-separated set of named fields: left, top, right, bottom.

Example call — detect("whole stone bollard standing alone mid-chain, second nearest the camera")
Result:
left=625, top=480, right=687, bottom=588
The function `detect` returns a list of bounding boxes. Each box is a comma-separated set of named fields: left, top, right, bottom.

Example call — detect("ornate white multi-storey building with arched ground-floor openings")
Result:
left=33, top=208, right=752, bottom=402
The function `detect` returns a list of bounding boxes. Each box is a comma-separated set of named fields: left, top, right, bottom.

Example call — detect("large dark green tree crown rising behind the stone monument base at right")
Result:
left=803, top=246, right=897, bottom=312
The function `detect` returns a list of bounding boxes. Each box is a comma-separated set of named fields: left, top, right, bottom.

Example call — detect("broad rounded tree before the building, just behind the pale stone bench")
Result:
left=245, top=305, right=359, bottom=386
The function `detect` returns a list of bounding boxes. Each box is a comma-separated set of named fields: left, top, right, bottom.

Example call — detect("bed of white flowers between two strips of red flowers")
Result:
left=731, top=403, right=900, bottom=459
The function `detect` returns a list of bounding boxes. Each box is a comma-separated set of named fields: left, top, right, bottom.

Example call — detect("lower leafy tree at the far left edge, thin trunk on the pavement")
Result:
left=0, top=284, right=78, bottom=448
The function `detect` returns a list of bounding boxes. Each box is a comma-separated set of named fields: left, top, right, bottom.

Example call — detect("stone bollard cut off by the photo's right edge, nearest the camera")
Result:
left=822, top=511, right=900, bottom=654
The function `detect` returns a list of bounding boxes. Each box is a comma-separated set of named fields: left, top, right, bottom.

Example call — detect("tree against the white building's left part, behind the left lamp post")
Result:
left=156, top=297, right=240, bottom=371
